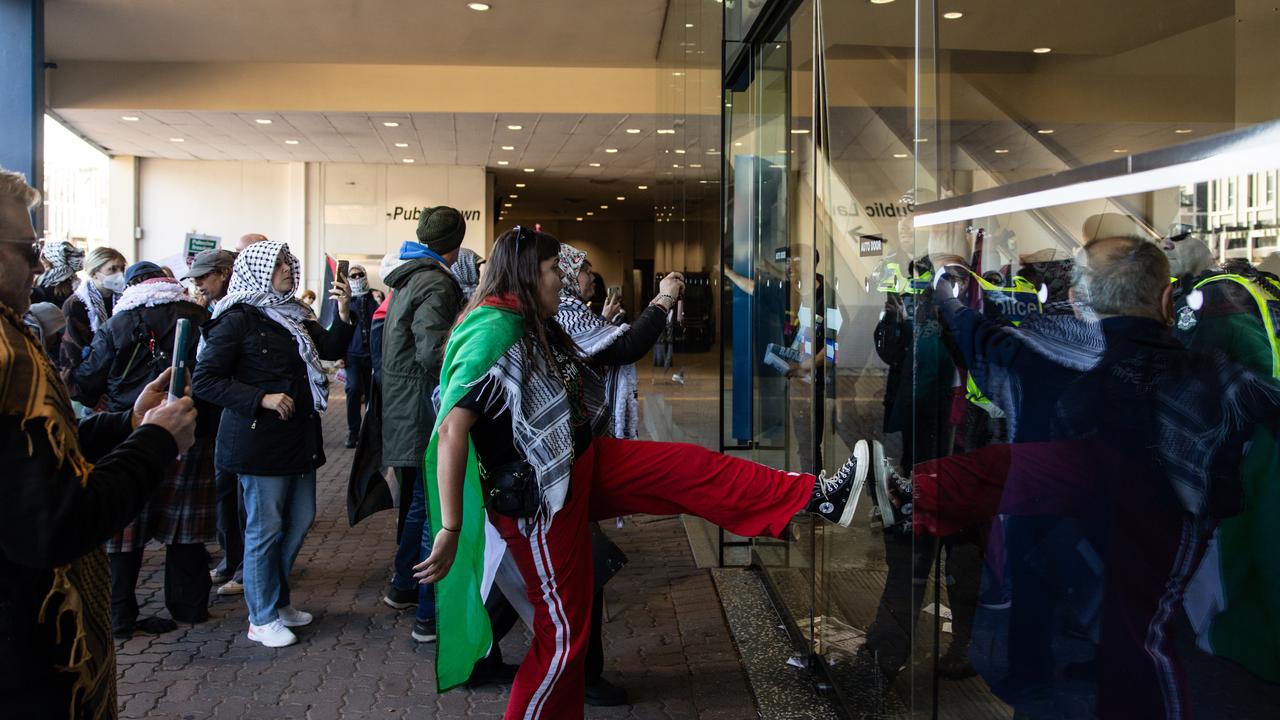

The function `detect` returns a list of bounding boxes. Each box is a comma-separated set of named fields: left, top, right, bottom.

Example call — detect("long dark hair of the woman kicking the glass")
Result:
left=454, top=225, right=580, bottom=361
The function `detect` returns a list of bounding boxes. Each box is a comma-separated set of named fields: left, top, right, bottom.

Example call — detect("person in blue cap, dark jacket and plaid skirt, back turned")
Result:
left=73, top=261, right=216, bottom=638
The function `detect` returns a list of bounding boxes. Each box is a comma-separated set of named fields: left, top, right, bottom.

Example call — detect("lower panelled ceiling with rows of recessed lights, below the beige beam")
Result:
left=58, top=109, right=719, bottom=218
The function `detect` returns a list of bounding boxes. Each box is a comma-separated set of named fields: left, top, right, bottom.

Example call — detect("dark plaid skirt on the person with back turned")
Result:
left=106, top=430, right=218, bottom=552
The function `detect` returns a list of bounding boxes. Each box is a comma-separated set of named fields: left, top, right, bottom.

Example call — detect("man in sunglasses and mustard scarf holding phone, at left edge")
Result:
left=0, top=169, right=196, bottom=717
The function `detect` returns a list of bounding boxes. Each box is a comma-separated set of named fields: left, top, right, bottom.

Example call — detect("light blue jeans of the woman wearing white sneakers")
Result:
left=239, top=471, right=316, bottom=625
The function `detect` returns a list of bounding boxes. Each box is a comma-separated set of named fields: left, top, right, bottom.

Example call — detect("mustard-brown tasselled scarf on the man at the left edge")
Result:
left=0, top=299, right=115, bottom=719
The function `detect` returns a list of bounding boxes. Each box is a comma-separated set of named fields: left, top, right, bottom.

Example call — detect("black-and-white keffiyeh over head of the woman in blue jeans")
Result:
left=212, top=240, right=329, bottom=411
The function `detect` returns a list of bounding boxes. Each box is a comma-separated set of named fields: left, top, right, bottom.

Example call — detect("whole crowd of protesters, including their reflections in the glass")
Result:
left=0, top=158, right=1280, bottom=719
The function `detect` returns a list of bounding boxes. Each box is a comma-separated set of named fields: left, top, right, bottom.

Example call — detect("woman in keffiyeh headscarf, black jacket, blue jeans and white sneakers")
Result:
left=193, top=241, right=352, bottom=647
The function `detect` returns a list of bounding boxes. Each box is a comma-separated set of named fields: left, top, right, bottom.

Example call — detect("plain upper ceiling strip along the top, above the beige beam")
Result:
left=45, top=0, right=675, bottom=67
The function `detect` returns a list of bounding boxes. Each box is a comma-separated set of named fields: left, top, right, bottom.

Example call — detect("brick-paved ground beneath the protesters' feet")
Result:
left=116, top=393, right=756, bottom=720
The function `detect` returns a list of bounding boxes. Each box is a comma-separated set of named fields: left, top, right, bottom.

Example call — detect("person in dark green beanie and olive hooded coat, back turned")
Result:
left=381, top=208, right=467, bottom=642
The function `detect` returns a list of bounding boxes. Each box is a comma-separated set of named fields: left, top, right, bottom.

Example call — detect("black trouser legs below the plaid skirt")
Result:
left=109, top=543, right=212, bottom=630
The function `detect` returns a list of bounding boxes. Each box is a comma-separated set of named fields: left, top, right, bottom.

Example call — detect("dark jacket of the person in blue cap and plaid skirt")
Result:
left=73, top=301, right=209, bottom=413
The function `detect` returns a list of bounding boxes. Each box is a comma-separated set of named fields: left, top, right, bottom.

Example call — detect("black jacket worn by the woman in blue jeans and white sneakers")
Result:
left=192, top=304, right=352, bottom=475
